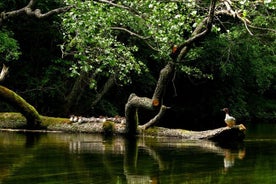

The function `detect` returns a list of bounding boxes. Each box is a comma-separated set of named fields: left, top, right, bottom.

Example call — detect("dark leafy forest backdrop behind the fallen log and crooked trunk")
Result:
left=0, top=0, right=276, bottom=130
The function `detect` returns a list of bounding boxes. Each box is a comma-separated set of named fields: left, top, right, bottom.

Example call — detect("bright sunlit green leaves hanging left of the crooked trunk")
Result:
left=61, top=0, right=209, bottom=88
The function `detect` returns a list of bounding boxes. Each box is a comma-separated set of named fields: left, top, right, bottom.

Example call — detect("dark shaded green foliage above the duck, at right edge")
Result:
left=196, top=20, right=276, bottom=119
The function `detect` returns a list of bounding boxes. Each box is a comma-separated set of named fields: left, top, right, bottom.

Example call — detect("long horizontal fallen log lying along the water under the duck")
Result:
left=0, top=113, right=245, bottom=143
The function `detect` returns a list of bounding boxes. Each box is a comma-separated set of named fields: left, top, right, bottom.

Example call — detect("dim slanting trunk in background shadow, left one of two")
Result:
left=64, top=72, right=88, bottom=114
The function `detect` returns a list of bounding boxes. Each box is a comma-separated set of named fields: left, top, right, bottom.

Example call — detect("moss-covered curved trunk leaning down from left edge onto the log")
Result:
left=0, top=86, right=41, bottom=129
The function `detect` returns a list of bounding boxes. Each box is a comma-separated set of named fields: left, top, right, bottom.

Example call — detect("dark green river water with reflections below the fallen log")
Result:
left=0, top=125, right=276, bottom=184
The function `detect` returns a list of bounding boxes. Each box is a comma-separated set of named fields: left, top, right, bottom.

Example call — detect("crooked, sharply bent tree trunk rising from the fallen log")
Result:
left=125, top=0, right=217, bottom=135
